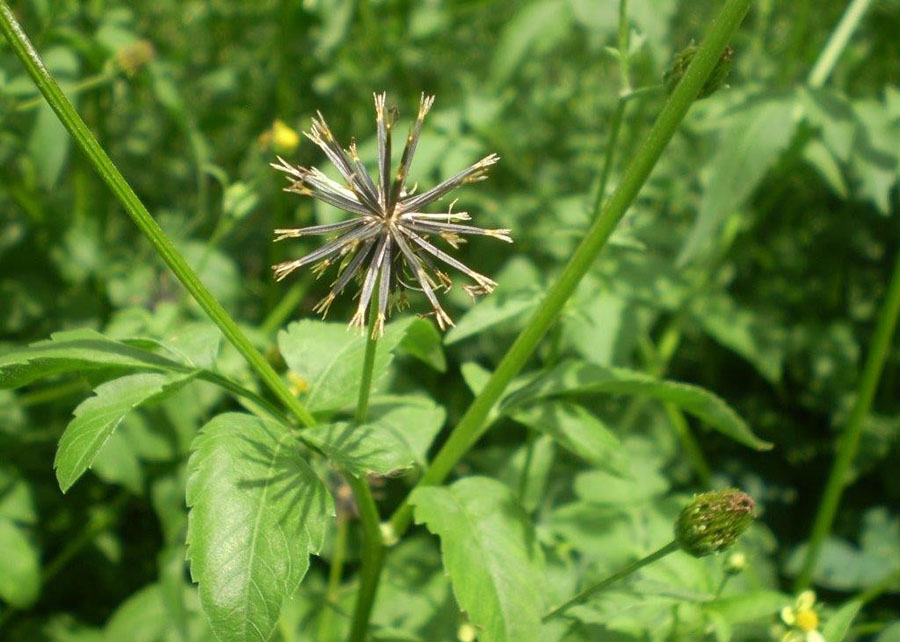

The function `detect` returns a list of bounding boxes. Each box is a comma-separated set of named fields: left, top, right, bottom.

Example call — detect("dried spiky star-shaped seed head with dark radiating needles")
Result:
left=272, top=93, right=512, bottom=336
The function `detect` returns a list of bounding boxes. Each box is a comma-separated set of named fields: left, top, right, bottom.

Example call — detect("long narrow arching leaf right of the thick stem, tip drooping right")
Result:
left=502, top=361, right=772, bottom=450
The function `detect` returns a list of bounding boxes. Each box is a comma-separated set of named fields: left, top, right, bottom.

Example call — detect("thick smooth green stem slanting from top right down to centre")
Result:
left=391, top=0, right=751, bottom=535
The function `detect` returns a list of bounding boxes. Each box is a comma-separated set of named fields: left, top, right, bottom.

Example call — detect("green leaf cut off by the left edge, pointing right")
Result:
left=0, top=330, right=187, bottom=388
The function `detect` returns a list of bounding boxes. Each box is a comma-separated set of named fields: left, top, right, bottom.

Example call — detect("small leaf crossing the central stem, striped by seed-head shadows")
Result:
left=297, top=422, right=418, bottom=477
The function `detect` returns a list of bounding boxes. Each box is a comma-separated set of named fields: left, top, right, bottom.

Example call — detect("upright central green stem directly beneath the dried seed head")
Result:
left=346, top=308, right=384, bottom=642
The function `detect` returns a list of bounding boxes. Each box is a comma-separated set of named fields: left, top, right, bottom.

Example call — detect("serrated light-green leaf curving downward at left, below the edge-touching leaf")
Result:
left=53, top=373, right=194, bottom=492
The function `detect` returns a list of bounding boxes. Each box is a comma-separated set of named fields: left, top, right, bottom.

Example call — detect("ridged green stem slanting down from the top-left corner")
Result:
left=0, top=0, right=315, bottom=426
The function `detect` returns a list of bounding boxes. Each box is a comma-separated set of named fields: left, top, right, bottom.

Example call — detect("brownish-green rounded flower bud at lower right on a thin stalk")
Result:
left=675, top=488, right=756, bottom=557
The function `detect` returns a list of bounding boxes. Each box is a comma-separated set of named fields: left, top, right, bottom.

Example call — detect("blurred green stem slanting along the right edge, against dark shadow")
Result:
left=794, top=251, right=900, bottom=591
